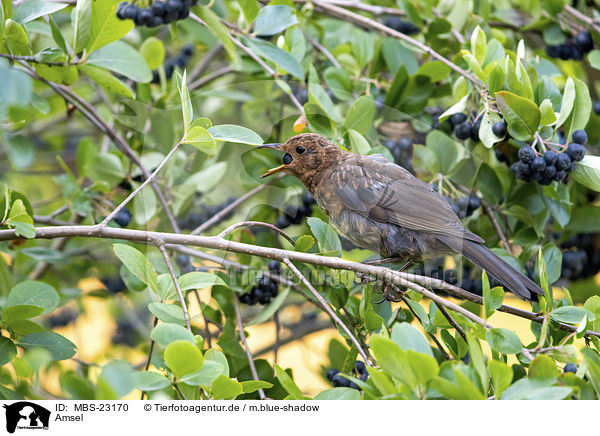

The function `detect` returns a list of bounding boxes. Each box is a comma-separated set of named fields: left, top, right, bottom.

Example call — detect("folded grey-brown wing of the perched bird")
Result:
left=330, top=155, right=483, bottom=242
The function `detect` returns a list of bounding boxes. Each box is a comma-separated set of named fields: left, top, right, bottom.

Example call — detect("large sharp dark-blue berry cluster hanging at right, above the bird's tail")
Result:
left=511, top=130, right=587, bottom=185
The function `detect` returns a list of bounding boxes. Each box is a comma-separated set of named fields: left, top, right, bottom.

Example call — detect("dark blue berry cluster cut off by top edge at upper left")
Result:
left=117, top=0, right=198, bottom=27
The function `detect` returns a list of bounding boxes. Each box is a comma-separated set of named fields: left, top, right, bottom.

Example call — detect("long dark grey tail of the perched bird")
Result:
left=452, top=239, right=544, bottom=301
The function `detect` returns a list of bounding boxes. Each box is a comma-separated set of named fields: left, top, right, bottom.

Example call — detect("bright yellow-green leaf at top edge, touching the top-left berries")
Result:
left=85, top=0, right=133, bottom=54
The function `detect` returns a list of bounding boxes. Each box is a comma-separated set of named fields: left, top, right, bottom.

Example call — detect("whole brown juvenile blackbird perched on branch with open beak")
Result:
left=261, top=133, right=544, bottom=301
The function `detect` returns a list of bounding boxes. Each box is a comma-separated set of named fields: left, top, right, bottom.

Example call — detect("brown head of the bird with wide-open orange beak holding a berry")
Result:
left=258, top=133, right=343, bottom=185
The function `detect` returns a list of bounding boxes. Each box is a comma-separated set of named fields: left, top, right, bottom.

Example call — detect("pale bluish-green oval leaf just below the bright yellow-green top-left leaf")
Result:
left=87, top=41, right=152, bottom=83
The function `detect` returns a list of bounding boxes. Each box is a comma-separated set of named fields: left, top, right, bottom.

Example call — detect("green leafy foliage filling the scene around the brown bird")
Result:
left=0, top=0, right=600, bottom=399
